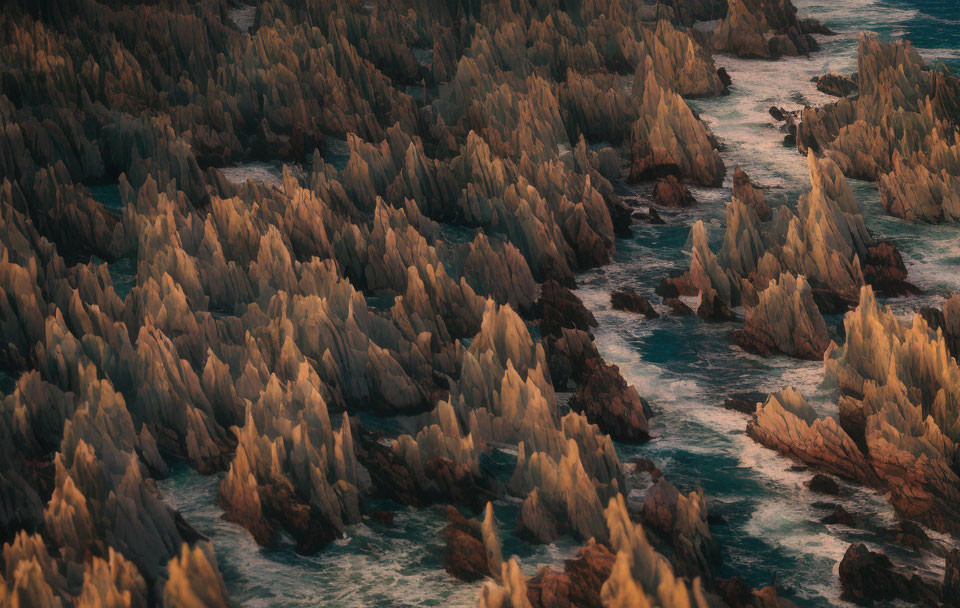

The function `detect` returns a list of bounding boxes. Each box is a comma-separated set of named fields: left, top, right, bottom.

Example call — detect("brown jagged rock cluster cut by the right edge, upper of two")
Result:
left=797, top=34, right=960, bottom=222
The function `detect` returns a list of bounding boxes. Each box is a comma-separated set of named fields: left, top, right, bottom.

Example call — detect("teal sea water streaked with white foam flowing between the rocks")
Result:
left=160, top=0, right=960, bottom=607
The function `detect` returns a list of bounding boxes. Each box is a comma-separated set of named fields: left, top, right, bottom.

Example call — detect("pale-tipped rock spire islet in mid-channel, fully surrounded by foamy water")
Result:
left=658, top=151, right=915, bottom=360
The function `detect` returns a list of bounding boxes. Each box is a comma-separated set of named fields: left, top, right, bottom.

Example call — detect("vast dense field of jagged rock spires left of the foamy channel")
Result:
left=0, top=0, right=806, bottom=606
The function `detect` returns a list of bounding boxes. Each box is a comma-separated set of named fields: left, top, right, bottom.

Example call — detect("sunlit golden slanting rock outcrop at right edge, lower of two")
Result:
left=747, top=287, right=960, bottom=531
